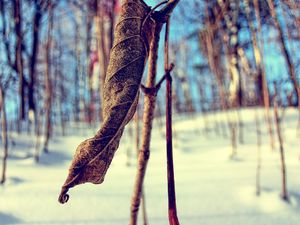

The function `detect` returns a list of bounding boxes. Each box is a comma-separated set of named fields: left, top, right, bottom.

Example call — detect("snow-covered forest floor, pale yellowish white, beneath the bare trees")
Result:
left=0, top=109, right=300, bottom=225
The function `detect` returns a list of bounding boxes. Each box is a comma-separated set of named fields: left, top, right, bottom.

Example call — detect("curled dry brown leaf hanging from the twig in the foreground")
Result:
left=59, top=0, right=154, bottom=203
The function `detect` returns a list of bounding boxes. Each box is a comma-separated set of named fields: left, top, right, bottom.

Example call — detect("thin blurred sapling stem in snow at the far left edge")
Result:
left=0, top=87, right=8, bottom=184
